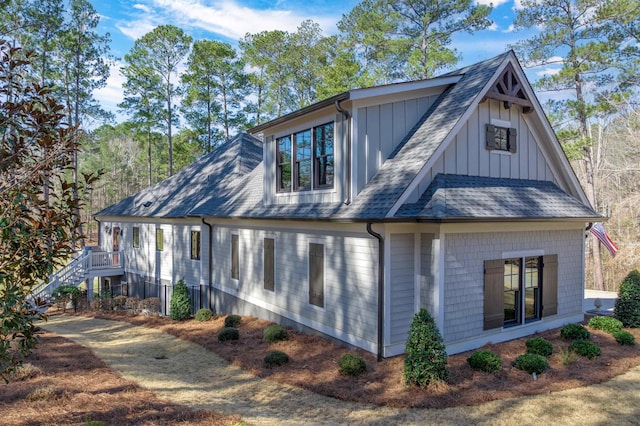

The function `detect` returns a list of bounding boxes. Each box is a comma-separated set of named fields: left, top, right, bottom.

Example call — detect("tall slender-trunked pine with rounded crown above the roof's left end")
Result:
left=125, top=25, right=192, bottom=176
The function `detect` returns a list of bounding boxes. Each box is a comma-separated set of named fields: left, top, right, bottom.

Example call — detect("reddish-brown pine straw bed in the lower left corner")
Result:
left=0, top=332, right=240, bottom=425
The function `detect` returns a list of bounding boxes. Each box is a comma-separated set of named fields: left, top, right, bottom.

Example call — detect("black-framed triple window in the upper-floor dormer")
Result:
left=276, top=123, right=335, bottom=192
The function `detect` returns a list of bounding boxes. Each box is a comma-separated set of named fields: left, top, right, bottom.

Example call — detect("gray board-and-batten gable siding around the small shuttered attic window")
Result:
left=407, top=99, right=557, bottom=202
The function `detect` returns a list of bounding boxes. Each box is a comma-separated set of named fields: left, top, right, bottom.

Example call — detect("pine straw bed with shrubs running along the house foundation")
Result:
left=90, top=313, right=640, bottom=408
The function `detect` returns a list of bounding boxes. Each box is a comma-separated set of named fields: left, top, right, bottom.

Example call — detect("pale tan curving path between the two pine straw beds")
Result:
left=43, top=316, right=640, bottom=425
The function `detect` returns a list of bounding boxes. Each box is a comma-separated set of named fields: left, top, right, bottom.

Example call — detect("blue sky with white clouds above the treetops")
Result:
left=94, top=0, right=548, bottom=116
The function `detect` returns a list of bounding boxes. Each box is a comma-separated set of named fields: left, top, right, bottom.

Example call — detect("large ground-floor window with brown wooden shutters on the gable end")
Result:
left=484, top=255, right=558, bottom=330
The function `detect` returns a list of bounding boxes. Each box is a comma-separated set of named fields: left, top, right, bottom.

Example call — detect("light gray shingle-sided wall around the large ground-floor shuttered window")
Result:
left=442, top=229, right=584, bottom=345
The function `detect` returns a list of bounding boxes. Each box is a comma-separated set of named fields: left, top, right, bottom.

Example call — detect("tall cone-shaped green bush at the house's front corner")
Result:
left=404, top=308, right=449, bottom=386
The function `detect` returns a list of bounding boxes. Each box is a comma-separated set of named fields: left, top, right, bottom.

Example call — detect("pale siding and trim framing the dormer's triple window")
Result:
left=263, top=113, right=348, bottom=204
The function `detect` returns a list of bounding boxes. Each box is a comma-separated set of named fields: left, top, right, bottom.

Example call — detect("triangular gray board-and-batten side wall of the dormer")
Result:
left=353, top=95, right=438, bottom=194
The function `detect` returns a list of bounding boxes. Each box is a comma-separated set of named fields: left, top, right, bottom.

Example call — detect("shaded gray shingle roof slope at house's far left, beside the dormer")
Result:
left=96, top=133, right=262, bottom=217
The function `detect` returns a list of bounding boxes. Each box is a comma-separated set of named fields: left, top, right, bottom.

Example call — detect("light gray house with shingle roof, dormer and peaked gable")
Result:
left=96, top=52, right=601, bottom=357
